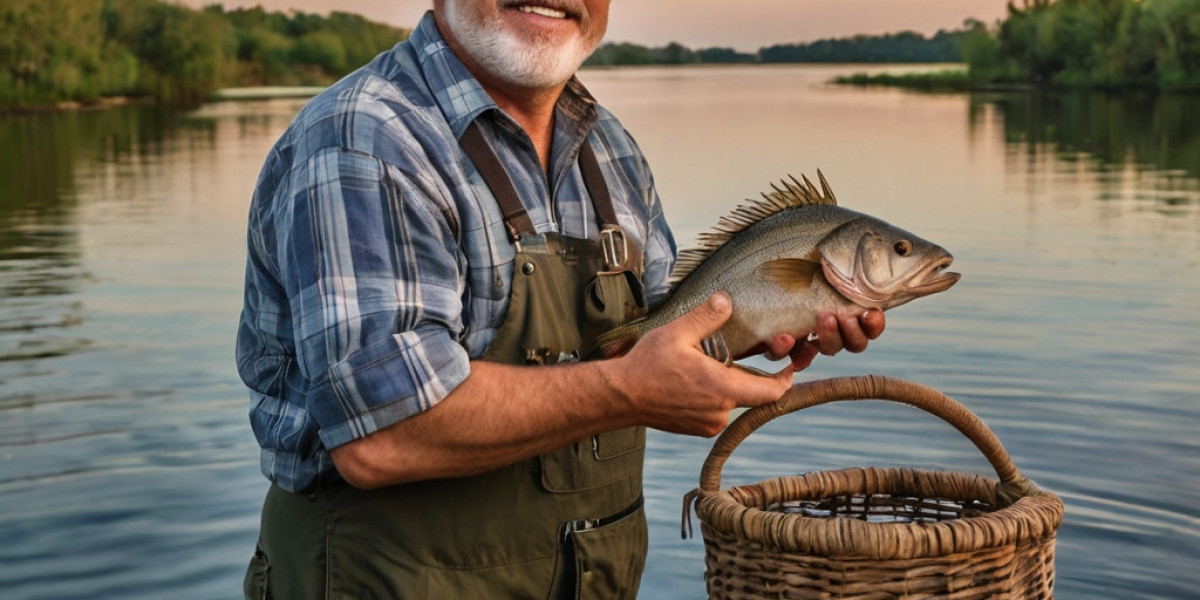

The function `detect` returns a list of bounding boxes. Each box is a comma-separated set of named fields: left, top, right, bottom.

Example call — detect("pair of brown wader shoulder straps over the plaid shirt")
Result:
left=458, top=121, right=619, bottom=241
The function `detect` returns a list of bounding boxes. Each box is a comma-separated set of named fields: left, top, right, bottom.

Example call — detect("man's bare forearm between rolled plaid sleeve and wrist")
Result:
left=330, top=360, right=634, bottom=488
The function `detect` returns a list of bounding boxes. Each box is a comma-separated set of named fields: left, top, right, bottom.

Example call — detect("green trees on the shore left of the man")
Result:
left=0, top=0, right=408, bottom=109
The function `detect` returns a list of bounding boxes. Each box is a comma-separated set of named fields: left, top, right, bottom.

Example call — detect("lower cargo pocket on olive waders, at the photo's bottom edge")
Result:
left=564, top=508, right=648, bottom=600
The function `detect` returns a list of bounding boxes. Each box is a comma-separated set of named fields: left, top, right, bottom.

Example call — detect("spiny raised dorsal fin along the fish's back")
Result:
left=667, top=169, right=838, bottom=289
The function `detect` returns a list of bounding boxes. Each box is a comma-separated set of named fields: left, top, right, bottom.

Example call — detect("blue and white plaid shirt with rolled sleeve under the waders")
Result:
left=238, top=14, right=676, bottom=491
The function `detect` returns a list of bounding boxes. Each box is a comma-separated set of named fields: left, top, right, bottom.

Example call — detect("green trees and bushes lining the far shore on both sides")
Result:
left=0, top=0, right=1200, bottom=112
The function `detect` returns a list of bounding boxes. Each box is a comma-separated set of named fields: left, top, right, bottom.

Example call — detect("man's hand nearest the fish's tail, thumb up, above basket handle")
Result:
left=607, top=292, right=793, bottom=437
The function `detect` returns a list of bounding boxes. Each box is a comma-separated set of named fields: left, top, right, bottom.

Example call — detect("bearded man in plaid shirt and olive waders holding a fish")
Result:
left=238, top=0, right=884, bottom=599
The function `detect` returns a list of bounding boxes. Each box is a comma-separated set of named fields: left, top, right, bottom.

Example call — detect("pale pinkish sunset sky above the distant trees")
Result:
left=189, top=0, right=1007, bottom=52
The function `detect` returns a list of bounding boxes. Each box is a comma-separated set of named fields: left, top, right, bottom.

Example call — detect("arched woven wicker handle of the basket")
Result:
left=700, top=374, right=1037, bottom=494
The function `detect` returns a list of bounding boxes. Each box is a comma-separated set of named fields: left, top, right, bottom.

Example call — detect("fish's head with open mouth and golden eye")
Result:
left=817, top=216, right=960, bottom=310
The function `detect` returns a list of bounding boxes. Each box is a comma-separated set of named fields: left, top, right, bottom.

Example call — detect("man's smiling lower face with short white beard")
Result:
left=442, top=0, right=610, bottom=89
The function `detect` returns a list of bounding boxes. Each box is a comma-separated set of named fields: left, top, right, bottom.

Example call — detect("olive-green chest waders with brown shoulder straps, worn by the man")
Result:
left=246, top=119, right=647, bottom=600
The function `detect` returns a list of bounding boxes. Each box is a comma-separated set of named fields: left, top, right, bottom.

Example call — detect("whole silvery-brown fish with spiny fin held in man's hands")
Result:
left=596, top=170, right=961, bottom=365
